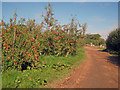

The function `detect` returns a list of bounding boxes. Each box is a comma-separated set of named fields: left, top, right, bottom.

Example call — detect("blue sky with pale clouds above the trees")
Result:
left=0, top=0, right=118, bottom=39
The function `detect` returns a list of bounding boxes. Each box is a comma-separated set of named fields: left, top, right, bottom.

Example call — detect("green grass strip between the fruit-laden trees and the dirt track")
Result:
left=2, top=48, right=86, bottom=88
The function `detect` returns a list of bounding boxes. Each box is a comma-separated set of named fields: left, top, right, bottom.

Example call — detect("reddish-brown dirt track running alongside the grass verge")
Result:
left=54, top=47, right=118, bottom=88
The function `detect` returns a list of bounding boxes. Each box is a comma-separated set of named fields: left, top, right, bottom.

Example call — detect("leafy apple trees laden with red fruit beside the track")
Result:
left=0, top=4, right=86, bottom=71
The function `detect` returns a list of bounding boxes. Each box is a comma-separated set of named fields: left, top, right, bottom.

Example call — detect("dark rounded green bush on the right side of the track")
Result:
left=106, top=28, right=120, bottom=52
